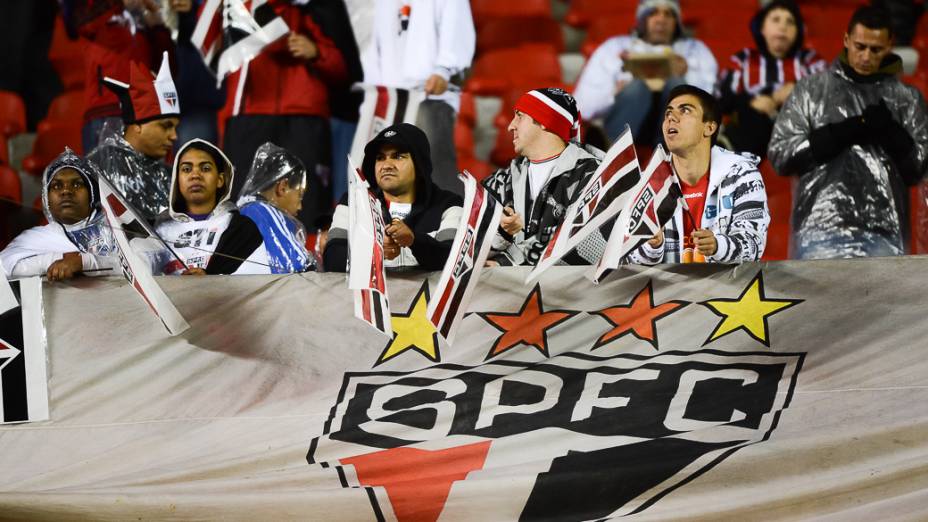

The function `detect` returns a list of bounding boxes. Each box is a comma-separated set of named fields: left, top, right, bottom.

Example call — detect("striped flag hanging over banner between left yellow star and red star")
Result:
left=426, top=170, right=503, bottom=344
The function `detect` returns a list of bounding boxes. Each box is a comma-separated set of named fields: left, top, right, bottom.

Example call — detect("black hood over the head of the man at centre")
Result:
left=361, top=123, right=433, bottom=204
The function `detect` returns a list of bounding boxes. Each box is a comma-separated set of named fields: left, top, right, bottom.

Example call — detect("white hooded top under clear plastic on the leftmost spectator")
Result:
left=0, top=148, right=119, bottom=278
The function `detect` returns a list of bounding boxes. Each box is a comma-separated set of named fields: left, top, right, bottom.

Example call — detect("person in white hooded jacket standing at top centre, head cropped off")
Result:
left=363, top=0, right=476, bottom=195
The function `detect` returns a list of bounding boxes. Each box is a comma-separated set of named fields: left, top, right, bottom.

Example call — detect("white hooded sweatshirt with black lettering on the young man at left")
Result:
left=149, top=139, right=267, bottom=275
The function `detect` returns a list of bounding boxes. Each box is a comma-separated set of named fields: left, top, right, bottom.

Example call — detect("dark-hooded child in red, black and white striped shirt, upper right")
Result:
left=715, top=0, right=827, bottom=157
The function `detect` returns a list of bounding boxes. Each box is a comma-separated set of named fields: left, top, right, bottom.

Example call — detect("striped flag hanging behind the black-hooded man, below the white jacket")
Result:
left=348, top=84, right=425, bottom=186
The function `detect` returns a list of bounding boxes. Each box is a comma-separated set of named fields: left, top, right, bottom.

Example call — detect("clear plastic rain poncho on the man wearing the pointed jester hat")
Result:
left=87, top=121, right=171, bottom=222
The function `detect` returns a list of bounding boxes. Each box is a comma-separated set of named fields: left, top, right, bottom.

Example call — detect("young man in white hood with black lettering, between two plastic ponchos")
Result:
left=145, top=139, right=267, bottom=275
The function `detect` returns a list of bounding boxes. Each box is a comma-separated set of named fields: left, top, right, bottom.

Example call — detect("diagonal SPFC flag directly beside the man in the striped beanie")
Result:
left=525, top=125, right=641, bottom=284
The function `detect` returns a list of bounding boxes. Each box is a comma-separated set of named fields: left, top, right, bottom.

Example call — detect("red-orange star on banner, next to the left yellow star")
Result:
left=477, top=284, right=580, bottom=360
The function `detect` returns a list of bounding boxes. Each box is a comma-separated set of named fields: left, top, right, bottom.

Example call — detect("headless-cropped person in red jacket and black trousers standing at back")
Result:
left=223, top=0, right=347, bottom=231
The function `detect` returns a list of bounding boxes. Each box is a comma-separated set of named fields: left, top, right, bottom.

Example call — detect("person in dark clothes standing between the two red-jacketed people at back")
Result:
left=168, top=0, right=225, bottom=143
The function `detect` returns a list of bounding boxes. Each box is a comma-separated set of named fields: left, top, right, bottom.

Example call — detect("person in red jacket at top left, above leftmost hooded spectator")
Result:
left=64, top=0, right=174, bottom=151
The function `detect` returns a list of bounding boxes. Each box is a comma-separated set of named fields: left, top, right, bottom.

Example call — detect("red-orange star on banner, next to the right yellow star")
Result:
left=592, top=279, right=689, bottom=350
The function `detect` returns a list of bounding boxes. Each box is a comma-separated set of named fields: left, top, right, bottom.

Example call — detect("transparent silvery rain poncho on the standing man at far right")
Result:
left=768, top=55, right=928, bottom=259
